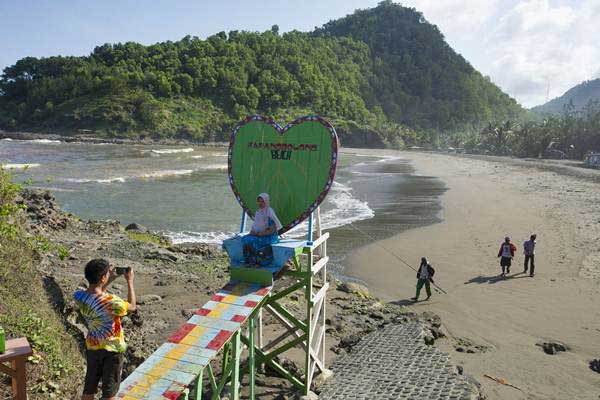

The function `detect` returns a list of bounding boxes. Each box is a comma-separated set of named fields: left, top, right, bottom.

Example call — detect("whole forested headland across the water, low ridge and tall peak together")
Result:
left=0, top=1, right=523, bottom=146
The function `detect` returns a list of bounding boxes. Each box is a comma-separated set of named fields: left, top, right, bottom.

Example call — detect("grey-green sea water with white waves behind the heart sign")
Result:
left=0, top=140, right=444, bottom=280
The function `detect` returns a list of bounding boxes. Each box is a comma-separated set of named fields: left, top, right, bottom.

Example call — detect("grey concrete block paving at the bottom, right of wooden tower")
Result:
left=319, top=323, right=479, bottom=400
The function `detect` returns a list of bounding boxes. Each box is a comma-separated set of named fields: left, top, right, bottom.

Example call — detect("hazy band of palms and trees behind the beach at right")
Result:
left=451, top=102, right=600, bottom=159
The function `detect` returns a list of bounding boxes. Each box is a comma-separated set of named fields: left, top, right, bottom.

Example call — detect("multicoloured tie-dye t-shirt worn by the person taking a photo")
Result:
left=73, top=290, right=129, bottom=353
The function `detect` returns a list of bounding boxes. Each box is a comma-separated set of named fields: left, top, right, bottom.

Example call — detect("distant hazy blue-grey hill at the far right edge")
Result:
left=531, top=78, right=600, bottom=114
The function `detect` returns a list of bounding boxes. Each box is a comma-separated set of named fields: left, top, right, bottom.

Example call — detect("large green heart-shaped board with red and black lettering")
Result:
left=228, top=115, right=338, bottom=234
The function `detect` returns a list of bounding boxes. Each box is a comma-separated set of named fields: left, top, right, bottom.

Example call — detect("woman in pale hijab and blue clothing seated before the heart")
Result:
left=242, top=193, right=282, bottom=266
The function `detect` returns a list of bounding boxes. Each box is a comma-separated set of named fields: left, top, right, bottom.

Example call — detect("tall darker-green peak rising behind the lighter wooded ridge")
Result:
left=316, top=1, right=522, bottom=131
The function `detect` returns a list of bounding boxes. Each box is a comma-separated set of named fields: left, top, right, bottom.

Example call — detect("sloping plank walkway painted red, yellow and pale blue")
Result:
left=117, top=282, right=272, bottom=400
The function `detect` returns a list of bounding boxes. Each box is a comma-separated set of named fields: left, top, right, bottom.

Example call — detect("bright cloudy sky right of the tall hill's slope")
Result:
left=403, top=0, right=600, bottom=107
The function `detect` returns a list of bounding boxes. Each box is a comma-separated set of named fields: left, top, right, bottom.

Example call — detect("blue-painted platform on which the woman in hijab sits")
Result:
left=223, top=235, right=308, bottom=274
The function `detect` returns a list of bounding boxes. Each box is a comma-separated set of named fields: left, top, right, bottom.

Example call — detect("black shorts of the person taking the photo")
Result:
left=83, top=350, right=123, bottom=398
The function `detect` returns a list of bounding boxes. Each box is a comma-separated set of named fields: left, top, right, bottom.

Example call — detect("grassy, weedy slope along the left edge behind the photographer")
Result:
left=0, top=167, right=83, bottom=399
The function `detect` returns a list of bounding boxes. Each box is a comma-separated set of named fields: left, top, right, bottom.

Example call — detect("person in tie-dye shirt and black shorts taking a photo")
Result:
left=73, top=259, right=136, bottom=400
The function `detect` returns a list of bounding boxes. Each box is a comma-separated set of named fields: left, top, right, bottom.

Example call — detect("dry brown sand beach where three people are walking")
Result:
left=346, top=152, right=600, bottom=400
